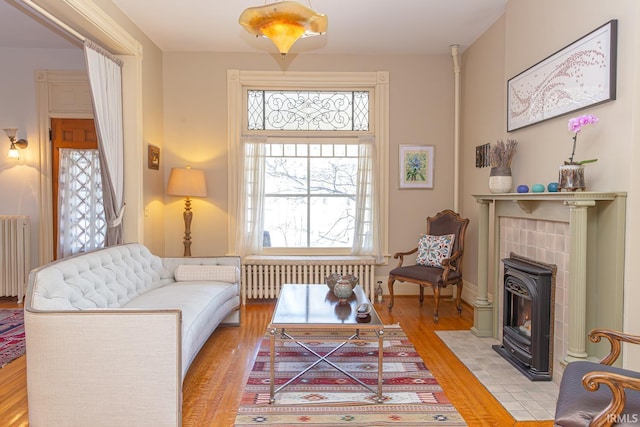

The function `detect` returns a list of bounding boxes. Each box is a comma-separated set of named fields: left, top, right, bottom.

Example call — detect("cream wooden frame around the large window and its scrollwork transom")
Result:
left=227, top=70, right=389, bottom=255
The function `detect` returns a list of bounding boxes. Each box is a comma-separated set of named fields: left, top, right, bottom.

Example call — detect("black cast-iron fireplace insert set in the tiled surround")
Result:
left=493, top=253, right=556, bottom=381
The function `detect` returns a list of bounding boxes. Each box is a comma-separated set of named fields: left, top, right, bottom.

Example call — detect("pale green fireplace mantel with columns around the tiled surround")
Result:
left=472, top=191, right=626, bottom=368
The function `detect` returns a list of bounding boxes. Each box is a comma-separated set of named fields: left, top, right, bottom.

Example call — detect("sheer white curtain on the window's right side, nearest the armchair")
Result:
left=351, top=135, right=384, bottom=263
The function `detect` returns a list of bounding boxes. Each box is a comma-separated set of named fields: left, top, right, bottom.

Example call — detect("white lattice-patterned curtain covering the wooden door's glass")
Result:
left=57, top=148, right=106, bottom=259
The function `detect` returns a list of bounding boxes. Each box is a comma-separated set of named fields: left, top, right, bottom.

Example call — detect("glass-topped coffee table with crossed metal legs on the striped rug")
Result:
left=268, top=284, right=384, bottom=403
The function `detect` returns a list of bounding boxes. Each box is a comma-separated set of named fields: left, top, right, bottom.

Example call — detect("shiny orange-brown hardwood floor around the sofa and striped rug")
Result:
left=0, top=296, right=553, bottom=427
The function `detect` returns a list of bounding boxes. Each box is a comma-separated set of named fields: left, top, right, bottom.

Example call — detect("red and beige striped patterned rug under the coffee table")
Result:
left=235, top=325, right=466, bottom=427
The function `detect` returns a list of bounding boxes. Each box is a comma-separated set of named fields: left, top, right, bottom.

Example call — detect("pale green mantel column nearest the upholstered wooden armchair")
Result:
left=471, top=199, right=493, bottom=337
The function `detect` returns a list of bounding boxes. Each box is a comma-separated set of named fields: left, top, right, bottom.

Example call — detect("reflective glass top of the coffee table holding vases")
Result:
left=271, top=284, right=382, bottom=329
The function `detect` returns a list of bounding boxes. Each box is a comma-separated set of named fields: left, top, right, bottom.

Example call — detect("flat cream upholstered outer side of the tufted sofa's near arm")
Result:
left=25, top=308, right=182, bottom=426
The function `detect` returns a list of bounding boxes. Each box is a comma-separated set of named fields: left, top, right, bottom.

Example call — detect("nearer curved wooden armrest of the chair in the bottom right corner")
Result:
left=582, top=371, right=640, bottom=426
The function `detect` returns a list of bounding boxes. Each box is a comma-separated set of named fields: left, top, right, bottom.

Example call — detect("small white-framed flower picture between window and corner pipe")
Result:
left=400, top=145, right=434, bottom=189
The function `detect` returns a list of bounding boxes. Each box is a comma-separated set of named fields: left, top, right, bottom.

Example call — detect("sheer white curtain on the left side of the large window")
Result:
left=236, top=136, right=267, bottom=256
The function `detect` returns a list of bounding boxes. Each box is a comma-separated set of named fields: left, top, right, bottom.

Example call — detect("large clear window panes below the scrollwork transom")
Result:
left=264, top=140, right=358, bottom=248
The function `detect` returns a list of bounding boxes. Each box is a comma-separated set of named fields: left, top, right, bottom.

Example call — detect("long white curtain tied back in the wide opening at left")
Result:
left=84, top=40, right=124, bottom=246
